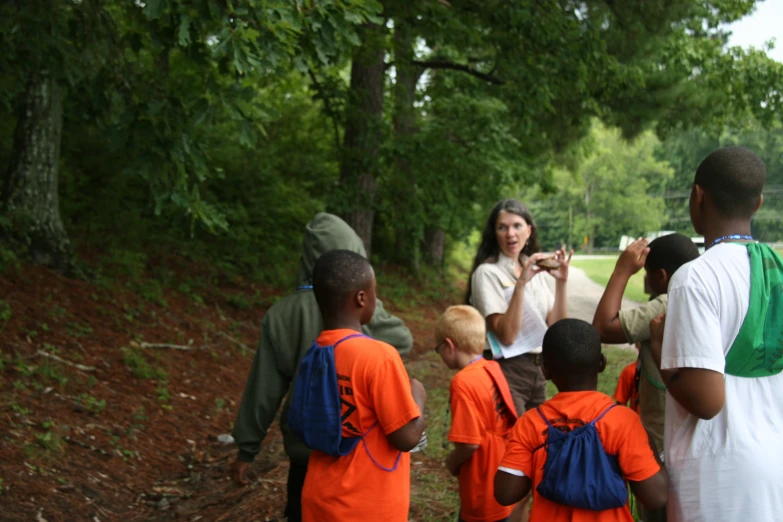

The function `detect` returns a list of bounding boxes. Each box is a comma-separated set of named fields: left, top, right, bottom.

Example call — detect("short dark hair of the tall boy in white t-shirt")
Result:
left=693, top=147, right=767, bottom=219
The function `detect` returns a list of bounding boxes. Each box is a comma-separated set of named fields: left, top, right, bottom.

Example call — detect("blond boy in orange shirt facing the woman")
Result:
left=435, top=305, right=517, bottom=522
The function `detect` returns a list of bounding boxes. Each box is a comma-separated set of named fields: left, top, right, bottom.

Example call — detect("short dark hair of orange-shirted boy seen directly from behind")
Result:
left=542, top=319, right=601, bottom=377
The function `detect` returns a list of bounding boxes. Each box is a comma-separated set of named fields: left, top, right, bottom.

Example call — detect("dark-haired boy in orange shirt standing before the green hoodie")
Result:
left=302, top=250, right=426, bottom=522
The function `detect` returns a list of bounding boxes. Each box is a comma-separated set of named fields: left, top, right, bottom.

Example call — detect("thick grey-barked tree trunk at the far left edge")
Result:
left=3, top=71, right=82, bottom=277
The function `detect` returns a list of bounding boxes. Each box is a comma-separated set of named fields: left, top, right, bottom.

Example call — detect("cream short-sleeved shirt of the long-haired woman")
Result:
left=470, top=253, right=555, bottom=358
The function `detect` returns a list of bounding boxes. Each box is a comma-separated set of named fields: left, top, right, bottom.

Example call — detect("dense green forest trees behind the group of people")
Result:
left=0, top=0, right=783, bottom=516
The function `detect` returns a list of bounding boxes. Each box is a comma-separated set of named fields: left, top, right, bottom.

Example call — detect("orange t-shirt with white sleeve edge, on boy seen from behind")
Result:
left=500, top=391, right=661, bottom=522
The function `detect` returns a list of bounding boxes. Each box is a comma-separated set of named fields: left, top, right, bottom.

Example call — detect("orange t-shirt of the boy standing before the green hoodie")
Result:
left=302, top=329, right=421, bottom=522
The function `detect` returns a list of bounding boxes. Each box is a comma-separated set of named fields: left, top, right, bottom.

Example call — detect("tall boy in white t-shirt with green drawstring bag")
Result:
left=650, top=147, right=783, bottom=522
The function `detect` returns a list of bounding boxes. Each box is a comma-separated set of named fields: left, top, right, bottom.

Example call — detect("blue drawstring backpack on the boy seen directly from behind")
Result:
left=536, top=404, right=628, bottom=511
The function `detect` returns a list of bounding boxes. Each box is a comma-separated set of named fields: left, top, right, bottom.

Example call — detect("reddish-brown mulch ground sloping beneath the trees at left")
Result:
left=0, top=254, right=460, bottom=521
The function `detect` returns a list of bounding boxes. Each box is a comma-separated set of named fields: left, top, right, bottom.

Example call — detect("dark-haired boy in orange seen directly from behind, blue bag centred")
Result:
left=495, top=319, right=668, bottom=522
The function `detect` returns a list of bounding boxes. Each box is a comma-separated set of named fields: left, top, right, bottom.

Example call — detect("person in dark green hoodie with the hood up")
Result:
left=231, top=213, right=413, bottom=522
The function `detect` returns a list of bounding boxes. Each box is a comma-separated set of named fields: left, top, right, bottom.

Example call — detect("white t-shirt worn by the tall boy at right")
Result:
left=661, top=244, right=783, bottom=522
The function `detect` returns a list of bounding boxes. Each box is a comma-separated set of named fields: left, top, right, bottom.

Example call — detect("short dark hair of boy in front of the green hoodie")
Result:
left=313, top=250, right=373, bottom=315
